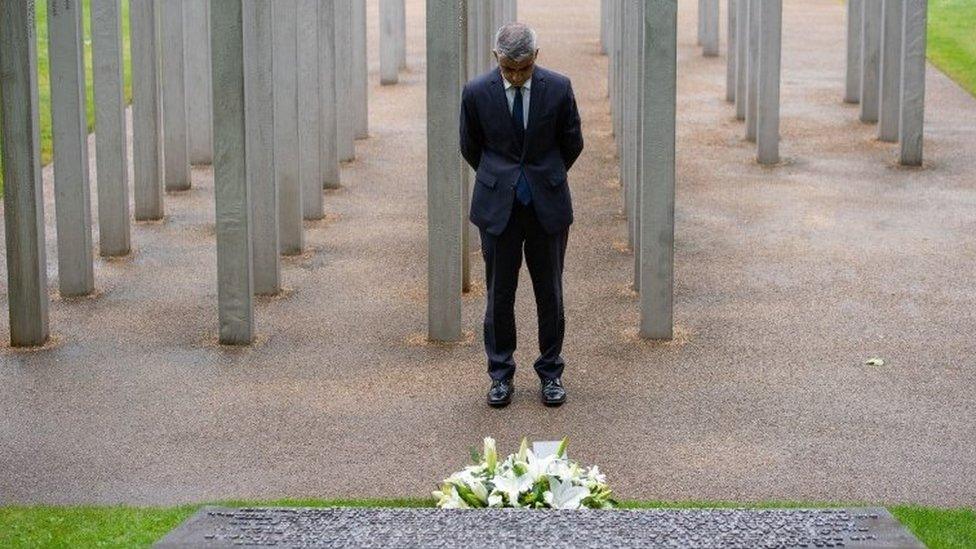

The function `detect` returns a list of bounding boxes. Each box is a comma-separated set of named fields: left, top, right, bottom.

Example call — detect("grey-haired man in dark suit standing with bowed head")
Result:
left=461, top=23, right=583, bottom=407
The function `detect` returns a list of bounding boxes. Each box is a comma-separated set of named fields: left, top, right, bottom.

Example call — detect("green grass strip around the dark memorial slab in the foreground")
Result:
left=0, top=499, right=976, bottom=549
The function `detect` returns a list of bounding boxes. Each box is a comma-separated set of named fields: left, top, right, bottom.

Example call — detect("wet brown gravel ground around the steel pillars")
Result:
left=0, top=0, right=976, bottom=504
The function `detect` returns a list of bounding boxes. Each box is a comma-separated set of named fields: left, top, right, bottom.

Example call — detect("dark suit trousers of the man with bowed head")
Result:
left=480, top=200, right=569, bottom=379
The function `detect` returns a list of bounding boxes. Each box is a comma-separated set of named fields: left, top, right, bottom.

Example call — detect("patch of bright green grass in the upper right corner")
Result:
left=927, top=0, right=976, bottom=95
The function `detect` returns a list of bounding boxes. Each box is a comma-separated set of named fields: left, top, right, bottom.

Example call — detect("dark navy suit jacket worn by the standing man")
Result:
left=461, top=66, right=583, bottom=235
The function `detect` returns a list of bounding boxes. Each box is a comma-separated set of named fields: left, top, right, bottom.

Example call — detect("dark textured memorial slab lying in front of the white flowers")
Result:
left=156, top=507, right=924, bottom=548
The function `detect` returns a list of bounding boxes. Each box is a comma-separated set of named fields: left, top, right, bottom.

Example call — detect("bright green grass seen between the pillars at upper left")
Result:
left=0, top=0, right=132, bottom=195
